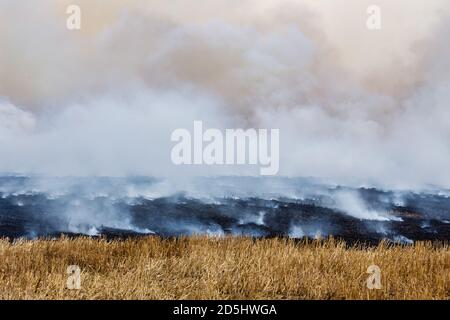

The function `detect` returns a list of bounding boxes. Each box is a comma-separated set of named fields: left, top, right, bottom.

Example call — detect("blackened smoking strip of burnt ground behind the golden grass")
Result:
left=0, top=176, right=450, bottom=244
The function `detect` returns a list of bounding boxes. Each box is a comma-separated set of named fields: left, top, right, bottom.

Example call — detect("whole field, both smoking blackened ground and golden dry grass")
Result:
left=0, top=176, right=450, bottom=299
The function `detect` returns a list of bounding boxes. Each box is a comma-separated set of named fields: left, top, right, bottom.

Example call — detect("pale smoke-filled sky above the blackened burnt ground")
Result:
left=0, top=0, right=450, bottom=190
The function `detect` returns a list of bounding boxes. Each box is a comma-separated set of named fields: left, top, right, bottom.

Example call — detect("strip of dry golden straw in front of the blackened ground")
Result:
left=0, top=237, right=450, bottom=299
